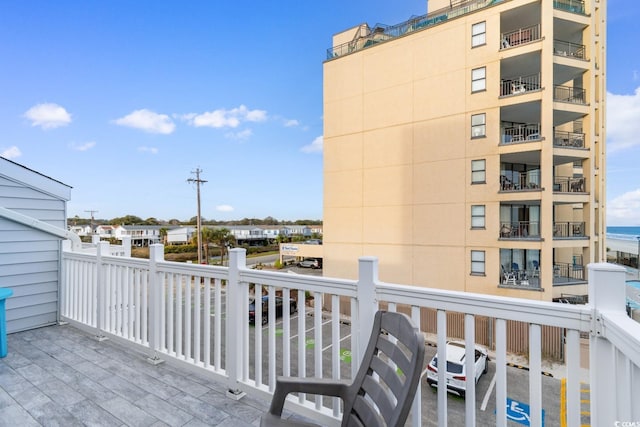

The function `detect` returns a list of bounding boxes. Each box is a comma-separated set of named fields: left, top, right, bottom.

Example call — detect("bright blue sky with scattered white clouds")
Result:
left=0, top=0, right=640, bottom=225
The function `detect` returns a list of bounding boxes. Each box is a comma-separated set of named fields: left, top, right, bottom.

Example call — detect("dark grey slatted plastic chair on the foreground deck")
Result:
left=260, top=311, right=424, bottom=427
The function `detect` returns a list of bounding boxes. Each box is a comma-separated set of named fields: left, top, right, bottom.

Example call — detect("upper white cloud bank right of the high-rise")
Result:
left=607, top=87, right=640, bottom=153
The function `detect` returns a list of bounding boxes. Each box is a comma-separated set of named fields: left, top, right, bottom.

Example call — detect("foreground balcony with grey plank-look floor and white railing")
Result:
left=0, top=244, right=640, bottom=426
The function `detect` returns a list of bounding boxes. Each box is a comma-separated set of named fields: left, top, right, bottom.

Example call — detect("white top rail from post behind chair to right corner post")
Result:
left=377, top=283, right=592, bottom=332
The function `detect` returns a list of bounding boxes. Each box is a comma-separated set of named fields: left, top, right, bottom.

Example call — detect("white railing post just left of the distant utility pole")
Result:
left=147, top=243, right=164, bottom=365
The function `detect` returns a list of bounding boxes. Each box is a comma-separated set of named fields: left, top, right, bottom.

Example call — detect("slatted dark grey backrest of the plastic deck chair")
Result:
left=342, top=311, right=424, bottom=427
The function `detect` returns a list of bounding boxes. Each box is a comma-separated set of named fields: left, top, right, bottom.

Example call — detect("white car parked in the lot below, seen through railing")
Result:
left=427, top=341, right=489, bottom=398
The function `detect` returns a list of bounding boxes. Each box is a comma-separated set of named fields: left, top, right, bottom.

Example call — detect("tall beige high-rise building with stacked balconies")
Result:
left=323, top=0, right=606, bottom=300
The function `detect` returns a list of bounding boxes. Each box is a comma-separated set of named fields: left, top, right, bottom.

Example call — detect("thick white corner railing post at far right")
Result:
left=587, top=263, right=626, bottom=426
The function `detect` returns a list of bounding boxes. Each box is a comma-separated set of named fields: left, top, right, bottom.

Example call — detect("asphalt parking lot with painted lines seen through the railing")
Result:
left=250, top=307, right=568, bottom=426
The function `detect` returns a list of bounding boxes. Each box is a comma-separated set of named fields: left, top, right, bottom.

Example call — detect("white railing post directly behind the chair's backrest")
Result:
left=354, top=257, right=378, bottom=366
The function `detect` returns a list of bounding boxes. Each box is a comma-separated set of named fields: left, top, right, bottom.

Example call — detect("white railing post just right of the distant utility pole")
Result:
left=225, top=248, right=248, bottom=400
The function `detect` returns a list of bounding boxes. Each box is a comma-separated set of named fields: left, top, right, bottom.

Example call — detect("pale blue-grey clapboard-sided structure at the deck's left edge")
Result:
left=0, top=157, right=81, bottom=332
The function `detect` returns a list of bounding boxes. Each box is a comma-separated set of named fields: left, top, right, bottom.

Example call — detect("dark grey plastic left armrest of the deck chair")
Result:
left=269, top=377, right=350, bottom=416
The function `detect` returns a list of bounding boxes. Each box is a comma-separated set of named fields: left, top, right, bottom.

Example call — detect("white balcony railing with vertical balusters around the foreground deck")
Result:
left=61, top=243, right=640, bottom=426
